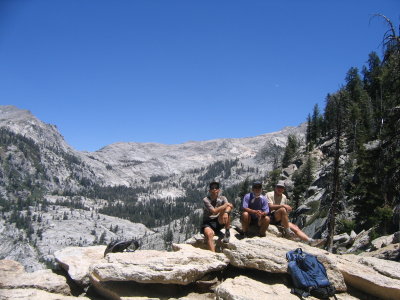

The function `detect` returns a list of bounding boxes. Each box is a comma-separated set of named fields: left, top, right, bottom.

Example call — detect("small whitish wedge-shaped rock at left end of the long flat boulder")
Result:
left=54, top=246, right=106, bottom=286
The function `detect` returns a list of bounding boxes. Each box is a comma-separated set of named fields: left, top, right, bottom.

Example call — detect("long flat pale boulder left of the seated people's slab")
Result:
left=90, top=244, right=229, bottom=285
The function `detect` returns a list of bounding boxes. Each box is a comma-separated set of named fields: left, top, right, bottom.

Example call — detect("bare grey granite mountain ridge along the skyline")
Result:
left=0, top=106, right=305, bottom=192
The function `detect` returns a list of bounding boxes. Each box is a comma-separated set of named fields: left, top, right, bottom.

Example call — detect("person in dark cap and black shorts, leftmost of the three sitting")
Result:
left=200, top=181, right=233, bottom=252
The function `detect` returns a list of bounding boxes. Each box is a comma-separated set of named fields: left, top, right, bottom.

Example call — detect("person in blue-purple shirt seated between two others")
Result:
left=241, top=182, right=269, bottom=237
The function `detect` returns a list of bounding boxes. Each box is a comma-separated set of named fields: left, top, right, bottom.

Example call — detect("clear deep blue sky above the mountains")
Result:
left=0, top=0, right=400, bottom=151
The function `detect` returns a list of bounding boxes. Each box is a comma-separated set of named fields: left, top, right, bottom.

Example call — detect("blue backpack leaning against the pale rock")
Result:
left=286, top=248, right=336, bottom=299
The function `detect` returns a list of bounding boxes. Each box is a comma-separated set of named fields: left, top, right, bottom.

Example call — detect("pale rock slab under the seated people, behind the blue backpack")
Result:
left=224, top=234, right=347, bottom=292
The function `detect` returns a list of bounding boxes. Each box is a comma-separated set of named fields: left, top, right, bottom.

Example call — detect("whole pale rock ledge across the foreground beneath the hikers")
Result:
left=0, top=229, right=400, bottom=300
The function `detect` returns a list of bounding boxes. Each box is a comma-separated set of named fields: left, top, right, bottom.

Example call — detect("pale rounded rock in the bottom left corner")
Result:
left=0, top=259, right=71, bottom=299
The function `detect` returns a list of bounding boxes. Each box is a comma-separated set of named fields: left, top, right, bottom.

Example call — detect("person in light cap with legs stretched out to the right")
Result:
left=267, top=180, right=324, bottom=246
